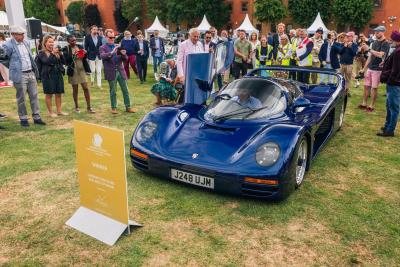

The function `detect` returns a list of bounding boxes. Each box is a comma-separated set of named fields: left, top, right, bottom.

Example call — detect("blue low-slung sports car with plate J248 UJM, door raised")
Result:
left=130, top=43, right=347, bottom=199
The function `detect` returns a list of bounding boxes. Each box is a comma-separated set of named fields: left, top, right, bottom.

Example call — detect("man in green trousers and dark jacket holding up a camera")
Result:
left=100, top=29, right=136, bottom=114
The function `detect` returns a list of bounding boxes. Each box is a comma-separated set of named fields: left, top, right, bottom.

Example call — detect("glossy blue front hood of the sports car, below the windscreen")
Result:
left=158, top=112, right=290, bottom=166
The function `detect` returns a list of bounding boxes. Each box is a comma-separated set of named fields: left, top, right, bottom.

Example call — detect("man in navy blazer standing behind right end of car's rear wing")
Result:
left=318, top=32, right=343, bottom=83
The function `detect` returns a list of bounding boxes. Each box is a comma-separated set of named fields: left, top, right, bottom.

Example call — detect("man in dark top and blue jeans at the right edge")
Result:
left=377, top=31, right=400, bottom=137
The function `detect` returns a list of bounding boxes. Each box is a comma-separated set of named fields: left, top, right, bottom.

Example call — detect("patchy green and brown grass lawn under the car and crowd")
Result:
left=0, top=70, right=400, bottom=266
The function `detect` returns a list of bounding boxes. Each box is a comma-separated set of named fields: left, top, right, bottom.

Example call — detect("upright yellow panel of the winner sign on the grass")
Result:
left=74, top=121, right=129, bottom=225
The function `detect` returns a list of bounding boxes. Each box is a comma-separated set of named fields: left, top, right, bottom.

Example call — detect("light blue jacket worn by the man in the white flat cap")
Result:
left=3, top=38, right=39, bottom=83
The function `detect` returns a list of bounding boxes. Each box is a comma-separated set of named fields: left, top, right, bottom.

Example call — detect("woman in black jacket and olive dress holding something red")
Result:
left=63, top=35, right=95, bottom=113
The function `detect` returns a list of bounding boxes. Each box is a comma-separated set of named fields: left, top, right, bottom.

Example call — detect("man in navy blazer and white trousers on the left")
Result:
left=84, top=25, right=103, bottom=88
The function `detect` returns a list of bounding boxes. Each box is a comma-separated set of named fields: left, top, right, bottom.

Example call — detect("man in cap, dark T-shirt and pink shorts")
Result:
left=358, top=26, right=390, bottom=112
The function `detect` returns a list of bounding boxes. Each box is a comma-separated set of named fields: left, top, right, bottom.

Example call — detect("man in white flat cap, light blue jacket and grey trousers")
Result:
left=3, top=26, right=46, bottom=127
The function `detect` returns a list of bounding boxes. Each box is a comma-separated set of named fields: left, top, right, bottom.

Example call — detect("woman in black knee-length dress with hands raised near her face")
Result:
left=36, top=35, right=68, bottom=117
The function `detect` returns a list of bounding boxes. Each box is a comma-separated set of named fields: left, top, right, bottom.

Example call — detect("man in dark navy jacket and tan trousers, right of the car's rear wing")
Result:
left=339, top=32, right=358, bottom=95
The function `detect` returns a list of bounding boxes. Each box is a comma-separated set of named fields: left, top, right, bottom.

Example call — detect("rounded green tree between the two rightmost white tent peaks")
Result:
left=254, top=0, right=287, bottom=25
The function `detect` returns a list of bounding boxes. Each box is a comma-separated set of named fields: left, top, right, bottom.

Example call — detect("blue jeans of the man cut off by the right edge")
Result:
left=385, top=85, right=400, bottom=132
